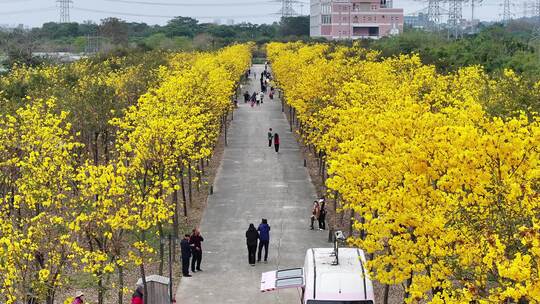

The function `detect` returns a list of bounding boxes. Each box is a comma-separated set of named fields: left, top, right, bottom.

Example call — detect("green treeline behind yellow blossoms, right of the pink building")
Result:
left=363, top=19, right=540, bottom=79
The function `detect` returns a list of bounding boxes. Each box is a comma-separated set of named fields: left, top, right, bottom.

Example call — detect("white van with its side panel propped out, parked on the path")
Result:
left=261, top=246, right=375, bottom=304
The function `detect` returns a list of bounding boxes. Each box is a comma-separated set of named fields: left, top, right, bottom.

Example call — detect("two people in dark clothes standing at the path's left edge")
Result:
left=180, top=228, right=204, bottom=278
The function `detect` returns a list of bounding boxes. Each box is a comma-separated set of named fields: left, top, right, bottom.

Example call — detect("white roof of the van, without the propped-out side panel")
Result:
left=306, top=248, right=375, bottom=301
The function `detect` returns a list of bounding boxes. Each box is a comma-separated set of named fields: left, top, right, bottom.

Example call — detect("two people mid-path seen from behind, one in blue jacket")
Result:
left=246, top=218, right=270, bottom=266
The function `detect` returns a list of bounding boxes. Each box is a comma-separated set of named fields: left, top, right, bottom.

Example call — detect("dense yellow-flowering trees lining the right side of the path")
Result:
left=268, top=43, right=540, bottom=303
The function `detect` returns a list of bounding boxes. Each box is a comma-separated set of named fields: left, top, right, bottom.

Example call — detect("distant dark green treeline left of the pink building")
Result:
left=0, top=16, right=309, bottom=52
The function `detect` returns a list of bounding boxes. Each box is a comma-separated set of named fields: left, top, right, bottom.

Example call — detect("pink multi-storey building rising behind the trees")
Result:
left=310, top=0, right=403, bottom=39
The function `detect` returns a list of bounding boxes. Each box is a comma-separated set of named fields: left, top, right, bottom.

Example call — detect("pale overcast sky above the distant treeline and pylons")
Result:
left=0, top=0, right=527, bottom=26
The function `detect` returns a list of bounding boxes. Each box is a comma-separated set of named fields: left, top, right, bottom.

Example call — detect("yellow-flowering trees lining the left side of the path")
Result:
left=0, top=45, right=251, bottom=304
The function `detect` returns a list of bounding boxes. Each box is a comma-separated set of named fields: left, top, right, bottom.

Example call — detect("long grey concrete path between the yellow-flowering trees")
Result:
left=176, top=65, right=331, bottom=304
